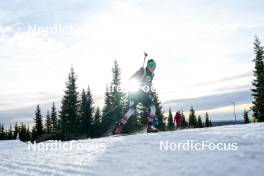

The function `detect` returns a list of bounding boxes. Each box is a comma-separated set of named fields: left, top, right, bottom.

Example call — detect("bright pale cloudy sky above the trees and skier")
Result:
left=0, top=0, right=264, bottom=125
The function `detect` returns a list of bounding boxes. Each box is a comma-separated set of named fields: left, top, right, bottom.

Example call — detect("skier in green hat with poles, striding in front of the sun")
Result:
left=113, top=59, right=159, bottom=134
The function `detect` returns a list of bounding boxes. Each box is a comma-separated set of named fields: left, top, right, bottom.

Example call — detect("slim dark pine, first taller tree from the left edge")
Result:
left=32, top=105, right=43, bottom=140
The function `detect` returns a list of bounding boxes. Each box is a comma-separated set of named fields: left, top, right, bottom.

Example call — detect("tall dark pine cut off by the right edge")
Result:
left=251, top=37, right=264, bottom=122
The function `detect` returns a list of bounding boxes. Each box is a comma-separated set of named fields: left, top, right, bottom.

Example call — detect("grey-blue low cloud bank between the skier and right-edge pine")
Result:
left=163, top=91, right=252, bottom=121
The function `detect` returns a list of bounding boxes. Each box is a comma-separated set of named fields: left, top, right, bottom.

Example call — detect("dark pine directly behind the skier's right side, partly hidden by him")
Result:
left=151, top=91, right=165, bottom=131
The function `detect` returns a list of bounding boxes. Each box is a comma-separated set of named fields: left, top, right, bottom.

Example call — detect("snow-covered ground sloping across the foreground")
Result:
left=0, top=123, right=264, bottom=176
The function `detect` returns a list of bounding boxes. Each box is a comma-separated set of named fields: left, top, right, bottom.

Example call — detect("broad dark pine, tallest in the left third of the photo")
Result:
left=60, top=68, right=80, bottom=140
